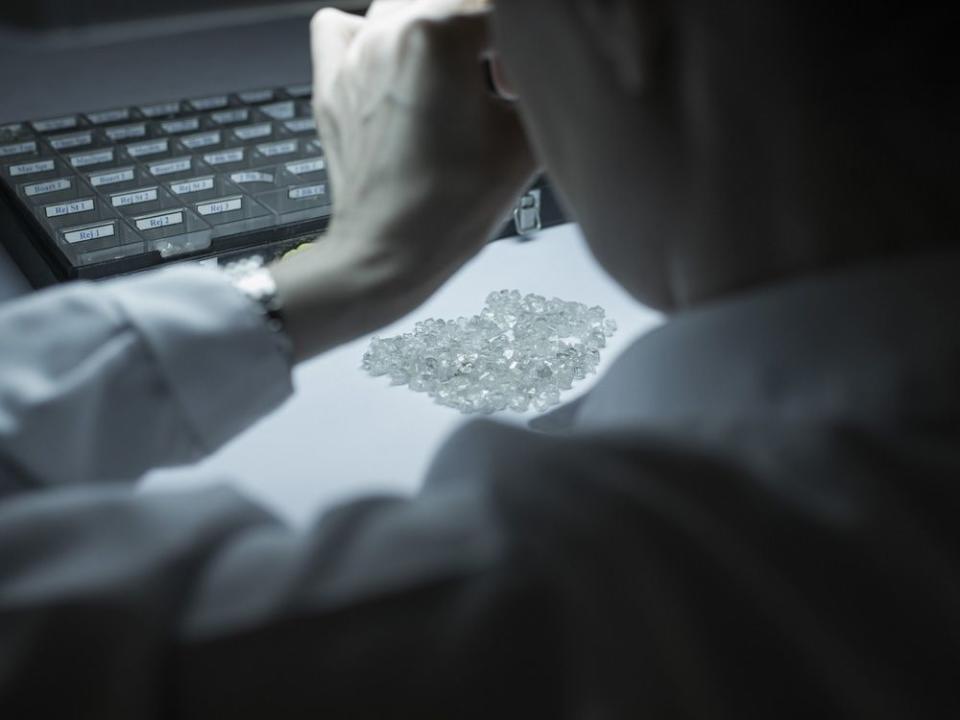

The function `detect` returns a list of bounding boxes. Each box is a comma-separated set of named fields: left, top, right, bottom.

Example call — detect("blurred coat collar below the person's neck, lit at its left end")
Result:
left=561, top=251, right=960, bottom=430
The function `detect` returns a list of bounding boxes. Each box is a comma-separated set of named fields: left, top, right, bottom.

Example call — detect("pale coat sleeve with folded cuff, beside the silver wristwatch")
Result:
left=0, top=266, right=292, bottom=496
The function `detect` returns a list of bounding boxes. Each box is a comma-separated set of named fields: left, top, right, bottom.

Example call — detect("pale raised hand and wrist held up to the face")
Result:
left=273, top=0, right=535, bottom=357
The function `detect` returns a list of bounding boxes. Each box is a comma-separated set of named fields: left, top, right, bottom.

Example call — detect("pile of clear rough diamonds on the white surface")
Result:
left=363, top=290, right=617, bottom=413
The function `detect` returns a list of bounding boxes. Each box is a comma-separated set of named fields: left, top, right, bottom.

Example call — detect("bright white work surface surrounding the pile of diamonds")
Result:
left=146, top=226, right=659, bottom=523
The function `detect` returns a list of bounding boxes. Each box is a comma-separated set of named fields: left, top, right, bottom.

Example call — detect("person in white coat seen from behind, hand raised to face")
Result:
left=0, top=0, right=960, bottom=720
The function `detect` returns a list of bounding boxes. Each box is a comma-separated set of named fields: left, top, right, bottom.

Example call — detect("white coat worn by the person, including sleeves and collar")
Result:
left=0, top=253, right=960, bottom=720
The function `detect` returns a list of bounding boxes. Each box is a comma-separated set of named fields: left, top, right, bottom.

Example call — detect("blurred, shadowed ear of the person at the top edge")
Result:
left=573, top=0, right=667, bottom=95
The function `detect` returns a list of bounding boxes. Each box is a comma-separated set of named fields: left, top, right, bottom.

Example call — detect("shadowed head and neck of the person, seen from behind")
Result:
left=494, top=0, right=960, bottom=309
